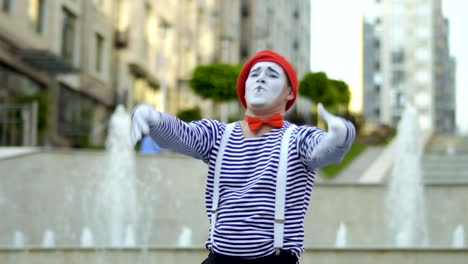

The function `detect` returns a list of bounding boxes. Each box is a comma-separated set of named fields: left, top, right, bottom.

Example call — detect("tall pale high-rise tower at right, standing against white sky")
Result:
left=364, top=0, right=454, bottom=133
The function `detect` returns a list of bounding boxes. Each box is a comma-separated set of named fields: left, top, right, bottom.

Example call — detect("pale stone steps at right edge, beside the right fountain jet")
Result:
left=421, top=135, right=468, bottom=183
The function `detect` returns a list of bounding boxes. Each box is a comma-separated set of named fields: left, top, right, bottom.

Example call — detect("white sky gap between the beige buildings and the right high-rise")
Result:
left=311, top=0, right=362, bottom=112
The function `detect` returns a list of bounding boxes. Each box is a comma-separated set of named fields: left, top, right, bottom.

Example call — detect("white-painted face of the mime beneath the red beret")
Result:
left=245, top=62, right=287, bottom=106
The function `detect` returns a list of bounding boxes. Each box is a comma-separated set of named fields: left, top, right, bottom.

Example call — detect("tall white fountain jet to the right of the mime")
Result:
left=385, top=104, right=427, bottom=247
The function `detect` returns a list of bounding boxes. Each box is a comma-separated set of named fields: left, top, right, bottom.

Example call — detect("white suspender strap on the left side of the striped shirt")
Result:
left=210, top=123, right=235, bottom=245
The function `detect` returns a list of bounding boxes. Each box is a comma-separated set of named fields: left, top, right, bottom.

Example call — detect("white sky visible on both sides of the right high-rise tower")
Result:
left=311, top=0, right=468, bottom=134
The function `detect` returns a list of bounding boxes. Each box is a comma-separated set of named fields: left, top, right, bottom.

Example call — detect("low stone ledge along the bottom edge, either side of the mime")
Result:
left=0, top=247, right=468, bottom=264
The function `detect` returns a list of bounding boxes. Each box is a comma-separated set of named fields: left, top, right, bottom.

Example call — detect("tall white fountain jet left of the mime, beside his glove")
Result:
left=94, top=105, right=140, bottom=247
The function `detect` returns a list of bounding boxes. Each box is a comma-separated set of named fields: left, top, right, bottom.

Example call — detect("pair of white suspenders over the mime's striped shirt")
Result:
left=210, top=123, right=296, bottom=254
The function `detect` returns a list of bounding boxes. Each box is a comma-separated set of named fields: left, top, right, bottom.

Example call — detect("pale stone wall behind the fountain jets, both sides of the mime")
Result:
left=0, top=150, right=468, bottom=249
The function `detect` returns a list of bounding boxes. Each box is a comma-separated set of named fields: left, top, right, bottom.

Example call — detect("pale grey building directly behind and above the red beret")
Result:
left=240, top=0, right=311, bottom=118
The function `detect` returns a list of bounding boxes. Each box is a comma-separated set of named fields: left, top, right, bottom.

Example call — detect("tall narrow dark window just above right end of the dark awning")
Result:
left=62, top=8, right=76, bottom=63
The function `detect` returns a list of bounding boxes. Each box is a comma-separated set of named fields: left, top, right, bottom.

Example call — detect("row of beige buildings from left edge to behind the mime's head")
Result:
left=0, top=0, right=310, bottom=147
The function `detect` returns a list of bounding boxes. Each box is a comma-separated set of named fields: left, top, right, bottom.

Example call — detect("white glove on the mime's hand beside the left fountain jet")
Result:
left=131, top=104, right=161, bottom=145
